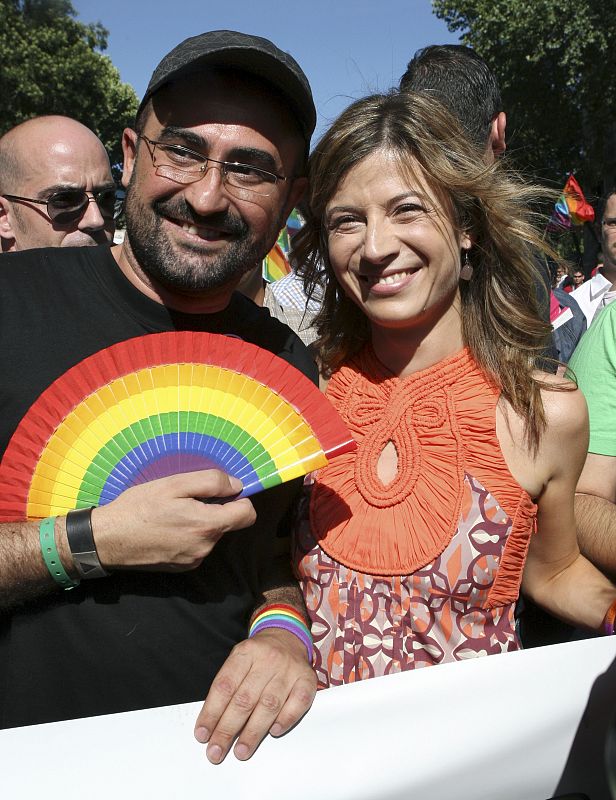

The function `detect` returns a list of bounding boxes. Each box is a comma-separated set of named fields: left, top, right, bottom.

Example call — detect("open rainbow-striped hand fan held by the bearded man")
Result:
left=0, top=331, right=356, bottom=521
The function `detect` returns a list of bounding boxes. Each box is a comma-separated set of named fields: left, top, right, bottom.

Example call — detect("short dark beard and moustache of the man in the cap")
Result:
left=125, top=181, right=285, bottom=294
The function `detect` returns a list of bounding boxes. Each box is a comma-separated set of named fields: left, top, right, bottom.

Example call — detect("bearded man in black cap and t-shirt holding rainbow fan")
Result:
left=0, top=31, right=316, bottom=763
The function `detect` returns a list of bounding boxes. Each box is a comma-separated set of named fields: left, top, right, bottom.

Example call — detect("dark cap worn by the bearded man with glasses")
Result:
left=137, top=31, right=317, bottom=144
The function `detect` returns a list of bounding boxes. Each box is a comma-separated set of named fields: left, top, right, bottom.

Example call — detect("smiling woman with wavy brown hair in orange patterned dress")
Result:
left=295, top=86, right=616, bottom=686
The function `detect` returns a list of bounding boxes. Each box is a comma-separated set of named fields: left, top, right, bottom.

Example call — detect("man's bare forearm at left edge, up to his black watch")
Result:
left=0, top=518, right=72, bottom=609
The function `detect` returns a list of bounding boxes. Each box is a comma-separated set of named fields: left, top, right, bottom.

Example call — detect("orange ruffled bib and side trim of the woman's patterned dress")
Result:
left=310, top=346, right=536, bottom=607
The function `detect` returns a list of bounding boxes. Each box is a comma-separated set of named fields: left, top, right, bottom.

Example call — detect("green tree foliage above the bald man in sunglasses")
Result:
left=0, top=0, right=138, bottom=170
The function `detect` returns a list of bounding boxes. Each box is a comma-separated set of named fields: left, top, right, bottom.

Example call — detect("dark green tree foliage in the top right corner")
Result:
left=432, top=0, right=616, bottom=200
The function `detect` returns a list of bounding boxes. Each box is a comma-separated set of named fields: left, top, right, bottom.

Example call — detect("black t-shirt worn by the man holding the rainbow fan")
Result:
left=0, top=247, right=317, bottom=728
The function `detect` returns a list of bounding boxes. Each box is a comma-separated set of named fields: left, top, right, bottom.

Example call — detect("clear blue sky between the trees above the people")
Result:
left=73, top=0, right=458, bottom=135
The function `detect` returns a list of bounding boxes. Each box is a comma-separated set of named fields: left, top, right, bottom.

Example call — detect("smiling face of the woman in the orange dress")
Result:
left=326, top=150, right=471, bottom=349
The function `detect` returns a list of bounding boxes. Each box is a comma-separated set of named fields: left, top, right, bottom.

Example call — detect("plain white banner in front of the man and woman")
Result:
left=0, top=637, right=616, bottom=800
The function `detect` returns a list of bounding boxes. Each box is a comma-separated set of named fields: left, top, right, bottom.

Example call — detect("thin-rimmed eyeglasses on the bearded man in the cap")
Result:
left=139, top=134, right=289, bottom=197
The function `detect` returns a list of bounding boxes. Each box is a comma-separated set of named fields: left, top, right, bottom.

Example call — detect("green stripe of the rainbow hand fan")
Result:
left=77, top=411, right=280, bottom=507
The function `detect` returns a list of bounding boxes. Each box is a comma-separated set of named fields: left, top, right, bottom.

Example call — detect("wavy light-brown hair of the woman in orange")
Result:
left=293, top=92, right=555, bottom=450
